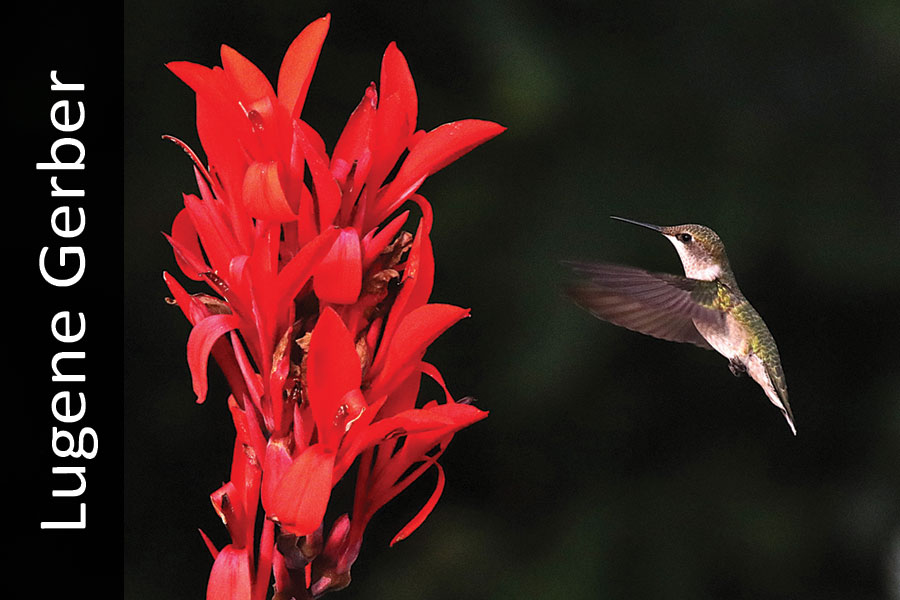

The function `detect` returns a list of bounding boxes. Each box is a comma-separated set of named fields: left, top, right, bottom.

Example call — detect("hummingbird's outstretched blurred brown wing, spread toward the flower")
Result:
left=565, top=262, right=725, bottom=350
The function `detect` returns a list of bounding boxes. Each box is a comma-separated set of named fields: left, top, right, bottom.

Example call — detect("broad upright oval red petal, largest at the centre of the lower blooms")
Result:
left=306, top=308, right=362, bottom=450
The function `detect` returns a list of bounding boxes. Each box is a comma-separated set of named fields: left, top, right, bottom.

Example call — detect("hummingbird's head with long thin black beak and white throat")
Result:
left=613, top=217, right=730, bottom=281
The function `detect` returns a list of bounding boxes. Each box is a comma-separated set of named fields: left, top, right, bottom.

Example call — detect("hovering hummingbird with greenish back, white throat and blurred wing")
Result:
left=566, top=217, right=797, bottom=435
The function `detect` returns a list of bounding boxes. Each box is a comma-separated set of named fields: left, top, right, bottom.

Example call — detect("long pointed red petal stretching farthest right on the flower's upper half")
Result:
left=368, top=119, right=506, bottom=229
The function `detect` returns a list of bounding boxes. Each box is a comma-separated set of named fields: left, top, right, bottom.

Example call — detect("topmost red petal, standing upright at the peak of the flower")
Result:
left=278, top=14, right=331, bottom=119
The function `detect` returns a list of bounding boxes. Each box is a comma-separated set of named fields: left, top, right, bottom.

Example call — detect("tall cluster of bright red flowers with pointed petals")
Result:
left=164, top=17, right=504, bottom=600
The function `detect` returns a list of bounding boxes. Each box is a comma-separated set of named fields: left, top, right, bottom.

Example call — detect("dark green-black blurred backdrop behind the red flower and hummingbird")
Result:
left=125, top=1, right=900, bottom=600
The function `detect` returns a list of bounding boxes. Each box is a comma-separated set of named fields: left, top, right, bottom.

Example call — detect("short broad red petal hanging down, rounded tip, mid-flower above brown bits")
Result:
left=313, top=227, right=362, bottom=304
